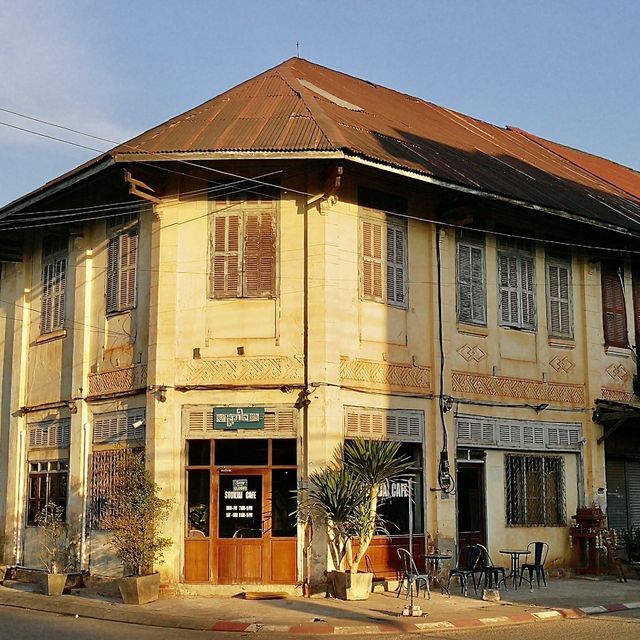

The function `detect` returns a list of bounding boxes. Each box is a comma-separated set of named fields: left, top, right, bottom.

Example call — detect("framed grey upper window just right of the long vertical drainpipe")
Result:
left=456, top=234, right=487, bottom=327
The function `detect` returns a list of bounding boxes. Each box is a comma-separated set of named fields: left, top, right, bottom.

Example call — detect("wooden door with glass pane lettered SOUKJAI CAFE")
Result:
left=212, top=469, right=271, bottom=584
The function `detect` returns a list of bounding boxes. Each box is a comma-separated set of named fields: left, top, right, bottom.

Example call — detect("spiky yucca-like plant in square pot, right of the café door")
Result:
left=297, top=439, right=412, bottom=600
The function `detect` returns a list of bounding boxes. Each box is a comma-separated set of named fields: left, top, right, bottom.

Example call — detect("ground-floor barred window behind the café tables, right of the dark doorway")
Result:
left=505, top=455, right=566, bottom=526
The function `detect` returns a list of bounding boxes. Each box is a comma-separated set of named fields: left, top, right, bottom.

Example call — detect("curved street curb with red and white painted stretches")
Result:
left=0, top=588, right=640, bottom=636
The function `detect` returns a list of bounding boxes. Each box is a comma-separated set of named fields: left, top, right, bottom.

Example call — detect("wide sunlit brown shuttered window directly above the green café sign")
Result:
left=209, top=187, right=278, bottom=298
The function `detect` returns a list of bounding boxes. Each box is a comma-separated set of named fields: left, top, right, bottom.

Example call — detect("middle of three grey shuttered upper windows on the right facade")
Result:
left=498, top=239, right=536, bottom=329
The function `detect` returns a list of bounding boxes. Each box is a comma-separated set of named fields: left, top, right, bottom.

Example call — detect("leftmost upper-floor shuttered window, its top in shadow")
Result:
left=40, top=236, right=69, bottom=335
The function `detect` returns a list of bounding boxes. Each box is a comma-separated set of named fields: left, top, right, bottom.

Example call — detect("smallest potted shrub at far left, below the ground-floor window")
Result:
left=36, top=502, right=71, bottom=596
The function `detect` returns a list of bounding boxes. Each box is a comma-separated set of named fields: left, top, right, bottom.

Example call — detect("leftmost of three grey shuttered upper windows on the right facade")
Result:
left=457, top=240, right=487, bottom=325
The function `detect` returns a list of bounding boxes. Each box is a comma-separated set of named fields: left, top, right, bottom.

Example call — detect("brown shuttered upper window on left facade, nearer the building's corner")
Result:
left=106, top=229, right=138, bottom=313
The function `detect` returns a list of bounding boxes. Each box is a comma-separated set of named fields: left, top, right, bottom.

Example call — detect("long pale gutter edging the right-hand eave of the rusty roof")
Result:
left=345, top=154, right=640, bottom=238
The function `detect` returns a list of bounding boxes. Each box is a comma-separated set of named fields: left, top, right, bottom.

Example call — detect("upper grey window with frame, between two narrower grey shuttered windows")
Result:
left=496, top=238, right=538, bottom=331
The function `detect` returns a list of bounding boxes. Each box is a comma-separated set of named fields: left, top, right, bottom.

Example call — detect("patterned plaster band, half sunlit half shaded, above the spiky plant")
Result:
left=340, top=356, right=431, bottom=393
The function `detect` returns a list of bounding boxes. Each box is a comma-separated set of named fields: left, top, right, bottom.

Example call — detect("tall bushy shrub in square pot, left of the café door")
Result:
left=103, top=450, right=172, bottom=604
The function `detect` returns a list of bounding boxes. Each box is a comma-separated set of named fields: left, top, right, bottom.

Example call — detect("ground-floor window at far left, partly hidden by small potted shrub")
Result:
left=25, top=459, right=69, bottom=527
